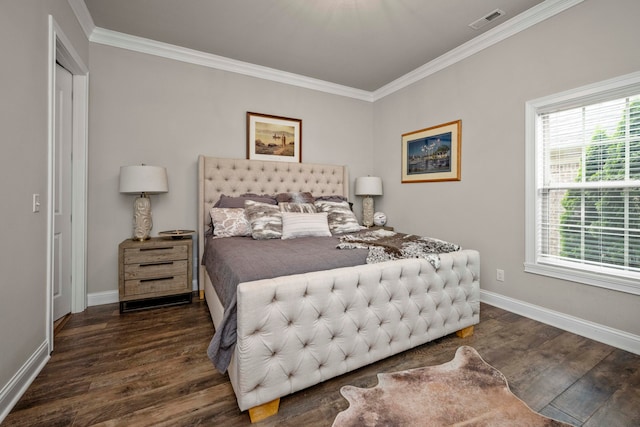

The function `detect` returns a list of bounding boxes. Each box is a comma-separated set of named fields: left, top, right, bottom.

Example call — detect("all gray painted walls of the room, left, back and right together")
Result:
left=0, top=0, right=640, bottom=418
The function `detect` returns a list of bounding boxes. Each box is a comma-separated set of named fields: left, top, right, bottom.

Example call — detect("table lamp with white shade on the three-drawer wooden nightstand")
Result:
left=120, top=164, right=169, bottom=240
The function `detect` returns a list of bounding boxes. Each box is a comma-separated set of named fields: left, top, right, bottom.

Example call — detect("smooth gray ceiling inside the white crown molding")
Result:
left=84, top=0, right=543, bottom=91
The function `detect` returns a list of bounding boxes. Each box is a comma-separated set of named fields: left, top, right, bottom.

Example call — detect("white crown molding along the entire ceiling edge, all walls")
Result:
left=68, top=0, right=584, bottom=102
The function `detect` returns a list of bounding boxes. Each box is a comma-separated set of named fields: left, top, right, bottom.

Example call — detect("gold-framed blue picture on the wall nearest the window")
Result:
left=402, top=120, right=462, bottom=183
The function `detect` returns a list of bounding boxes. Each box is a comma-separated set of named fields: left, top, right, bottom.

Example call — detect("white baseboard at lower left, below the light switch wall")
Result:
left=0, top=341, right=50, bottom=424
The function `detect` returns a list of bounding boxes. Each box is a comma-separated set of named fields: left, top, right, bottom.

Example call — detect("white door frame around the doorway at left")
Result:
left=46, top=15, right=89, bottom=353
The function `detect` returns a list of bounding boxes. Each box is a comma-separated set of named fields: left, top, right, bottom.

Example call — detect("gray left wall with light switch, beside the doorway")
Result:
left=0, top=0, right=89, bottom=404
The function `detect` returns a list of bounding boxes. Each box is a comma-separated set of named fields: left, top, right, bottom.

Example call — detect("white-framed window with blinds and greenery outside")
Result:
left=525, top=73, right=640, bottom=295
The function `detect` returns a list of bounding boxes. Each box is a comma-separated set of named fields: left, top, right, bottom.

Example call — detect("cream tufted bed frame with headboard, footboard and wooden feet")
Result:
left=198, top=155, right=480, bottom=422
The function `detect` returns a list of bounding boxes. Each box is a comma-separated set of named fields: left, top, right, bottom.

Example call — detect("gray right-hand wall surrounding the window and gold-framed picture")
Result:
left=373, top=0, right=640, bottom=335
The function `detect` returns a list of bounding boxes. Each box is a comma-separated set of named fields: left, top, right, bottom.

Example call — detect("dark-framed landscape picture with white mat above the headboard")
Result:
left=247, top=112, right=302, bottom=163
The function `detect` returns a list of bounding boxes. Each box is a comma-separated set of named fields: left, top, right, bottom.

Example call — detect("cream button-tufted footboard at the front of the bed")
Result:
left=229, top=250, right=480, bottom=410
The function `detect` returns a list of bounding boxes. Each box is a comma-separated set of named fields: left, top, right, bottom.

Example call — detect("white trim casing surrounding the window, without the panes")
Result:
left=524, top=72, right=640, bottom=295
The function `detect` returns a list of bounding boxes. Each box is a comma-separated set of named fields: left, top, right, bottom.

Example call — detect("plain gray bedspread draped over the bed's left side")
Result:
left=202, top=237, right=369, bottom=373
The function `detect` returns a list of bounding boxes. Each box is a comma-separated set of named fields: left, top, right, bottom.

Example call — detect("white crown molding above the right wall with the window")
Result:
left=372, top=0, right=584, bottom=101
